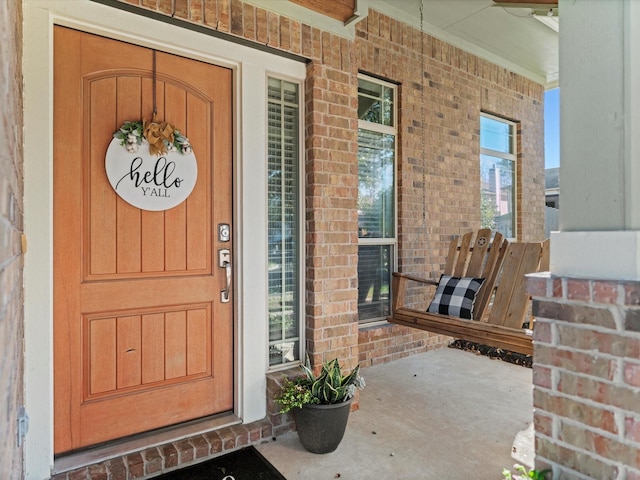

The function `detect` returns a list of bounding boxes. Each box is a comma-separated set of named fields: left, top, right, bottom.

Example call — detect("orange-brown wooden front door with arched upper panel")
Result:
left=52, top=27, right=233, bottom=453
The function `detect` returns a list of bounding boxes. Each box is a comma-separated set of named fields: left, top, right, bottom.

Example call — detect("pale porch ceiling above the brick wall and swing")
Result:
left=370, top=0, right=559, bottom=88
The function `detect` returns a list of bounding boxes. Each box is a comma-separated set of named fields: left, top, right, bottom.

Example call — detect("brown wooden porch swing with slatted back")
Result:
left=388, top=229, right=549, bottom=355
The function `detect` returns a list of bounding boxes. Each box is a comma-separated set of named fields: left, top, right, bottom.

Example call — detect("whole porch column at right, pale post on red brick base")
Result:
left=528, top=0, right=640, bottom=480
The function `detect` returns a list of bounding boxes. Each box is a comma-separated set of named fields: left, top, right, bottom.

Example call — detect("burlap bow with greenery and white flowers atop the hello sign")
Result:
left=113, top=114, right=193, bottom=156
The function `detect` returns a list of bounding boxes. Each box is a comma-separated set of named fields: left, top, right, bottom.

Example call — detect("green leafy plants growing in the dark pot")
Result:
left=275, top=357, right=365, bottom=413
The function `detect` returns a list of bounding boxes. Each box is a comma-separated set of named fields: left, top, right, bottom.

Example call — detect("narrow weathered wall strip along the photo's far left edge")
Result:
left=0, top=2, right=24, bottom=478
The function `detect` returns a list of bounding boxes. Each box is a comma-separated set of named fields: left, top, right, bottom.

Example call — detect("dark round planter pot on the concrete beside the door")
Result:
left=291, top=398, right=353, bottom=453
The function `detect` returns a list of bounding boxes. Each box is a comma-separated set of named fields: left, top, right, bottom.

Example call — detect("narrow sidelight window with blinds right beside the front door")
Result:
left=267, top=78, right=302, bottom=367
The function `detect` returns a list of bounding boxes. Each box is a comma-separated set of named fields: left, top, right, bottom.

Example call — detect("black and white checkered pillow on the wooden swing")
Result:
left=427, top=275, right=484, bottom=320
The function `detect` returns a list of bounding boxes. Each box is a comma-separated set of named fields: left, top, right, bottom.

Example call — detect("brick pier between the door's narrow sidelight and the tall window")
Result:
left=305, top=50, right=358, bottom=369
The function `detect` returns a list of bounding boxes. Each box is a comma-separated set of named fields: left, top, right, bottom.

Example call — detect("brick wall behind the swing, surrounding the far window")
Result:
left=356, top=10, right=544, bottom=365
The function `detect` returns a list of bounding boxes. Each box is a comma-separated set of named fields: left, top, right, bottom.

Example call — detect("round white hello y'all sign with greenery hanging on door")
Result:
left=105, top=122, right=198, bottom=211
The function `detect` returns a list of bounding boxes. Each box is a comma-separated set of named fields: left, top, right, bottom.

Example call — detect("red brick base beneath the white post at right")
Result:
left=528, top=274, right=640, bottom=480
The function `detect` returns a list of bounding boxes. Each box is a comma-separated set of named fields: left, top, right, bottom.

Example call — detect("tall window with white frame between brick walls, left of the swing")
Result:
left=358, top=76, right=397, bottom=324
